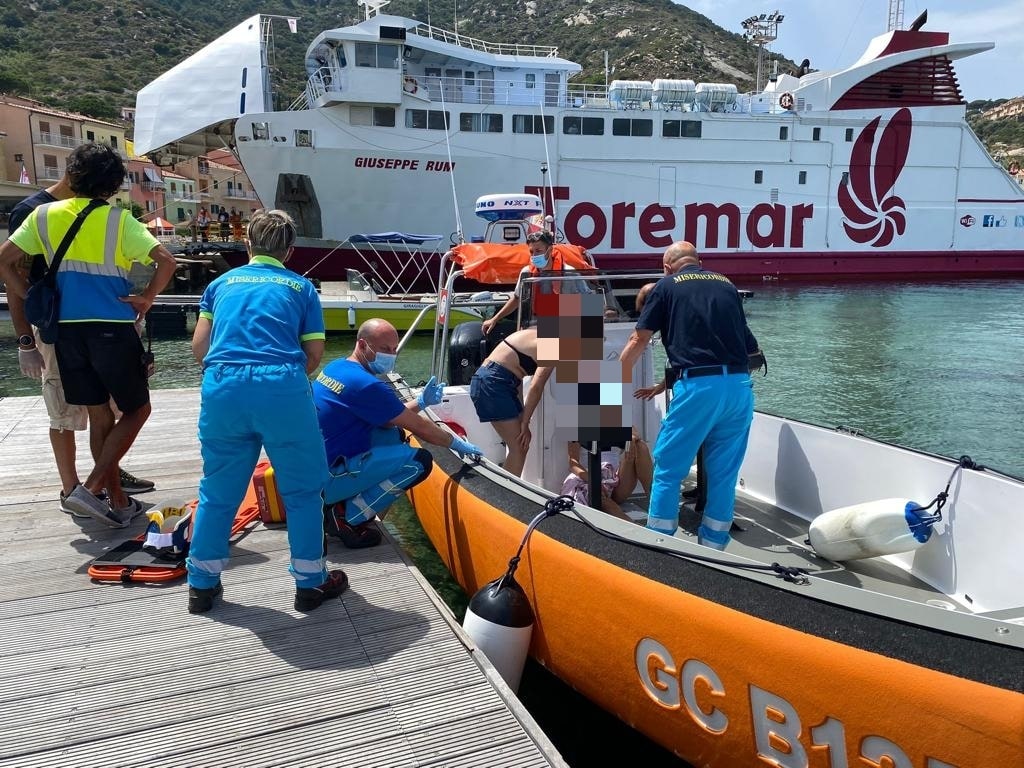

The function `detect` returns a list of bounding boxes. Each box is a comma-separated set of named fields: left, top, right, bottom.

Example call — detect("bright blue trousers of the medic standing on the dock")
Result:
left=187, top=365, right=327, bottom=589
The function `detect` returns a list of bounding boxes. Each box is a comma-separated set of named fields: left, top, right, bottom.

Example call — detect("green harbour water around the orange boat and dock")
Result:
left=0, top=281, right=1024, bottom=768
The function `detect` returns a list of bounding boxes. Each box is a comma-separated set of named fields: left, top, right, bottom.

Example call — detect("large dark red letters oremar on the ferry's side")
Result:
left=563, top=202, right=814, bottom=251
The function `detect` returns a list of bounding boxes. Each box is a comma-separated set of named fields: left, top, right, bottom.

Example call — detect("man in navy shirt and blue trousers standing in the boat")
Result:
left=621, top=242, right=758, bottom=549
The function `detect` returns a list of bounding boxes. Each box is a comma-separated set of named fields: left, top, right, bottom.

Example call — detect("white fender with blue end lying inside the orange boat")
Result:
left=809, top=499, right=941, bottom=561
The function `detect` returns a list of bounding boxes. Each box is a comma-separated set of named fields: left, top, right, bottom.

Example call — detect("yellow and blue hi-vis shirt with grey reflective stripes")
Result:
left=10, top=198, right=160, bottom=323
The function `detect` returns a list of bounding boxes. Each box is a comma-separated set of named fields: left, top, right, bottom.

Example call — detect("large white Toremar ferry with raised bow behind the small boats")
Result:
left=135, top=0, right=1024, bottom=280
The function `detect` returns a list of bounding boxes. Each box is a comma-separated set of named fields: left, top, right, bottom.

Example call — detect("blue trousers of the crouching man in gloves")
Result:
left=324, top=442, right=432, bottom=525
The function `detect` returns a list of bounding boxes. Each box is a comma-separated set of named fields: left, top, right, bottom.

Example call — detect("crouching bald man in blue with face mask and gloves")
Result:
left=313, top=318, right=481, bottom=548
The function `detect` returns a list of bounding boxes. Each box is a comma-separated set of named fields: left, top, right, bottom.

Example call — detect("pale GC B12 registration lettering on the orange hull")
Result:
left=636, top=637, right=956, bottom=768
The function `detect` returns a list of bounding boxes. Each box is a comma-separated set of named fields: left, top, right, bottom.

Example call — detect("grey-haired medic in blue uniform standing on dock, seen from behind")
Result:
left=187, top=211, right=348, bottom=613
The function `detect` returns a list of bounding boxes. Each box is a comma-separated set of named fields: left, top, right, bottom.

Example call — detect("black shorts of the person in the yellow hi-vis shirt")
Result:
left=55, top=323, right=150, bottom=414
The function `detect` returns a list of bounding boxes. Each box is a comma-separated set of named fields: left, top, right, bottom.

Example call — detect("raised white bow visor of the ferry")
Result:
left=135, top=14, right=271, bottom=160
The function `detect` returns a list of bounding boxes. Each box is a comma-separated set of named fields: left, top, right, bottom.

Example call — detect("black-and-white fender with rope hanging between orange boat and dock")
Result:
left=462, top=496, right=573, bottom=691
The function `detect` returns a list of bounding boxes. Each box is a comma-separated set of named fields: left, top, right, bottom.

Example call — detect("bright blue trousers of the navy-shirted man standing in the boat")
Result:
left=647, top=374, right=754, bottom=549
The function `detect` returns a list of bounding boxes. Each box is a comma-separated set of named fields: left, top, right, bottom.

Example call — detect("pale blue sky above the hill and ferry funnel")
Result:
left=677, top=0, right=1024, bottom=101
